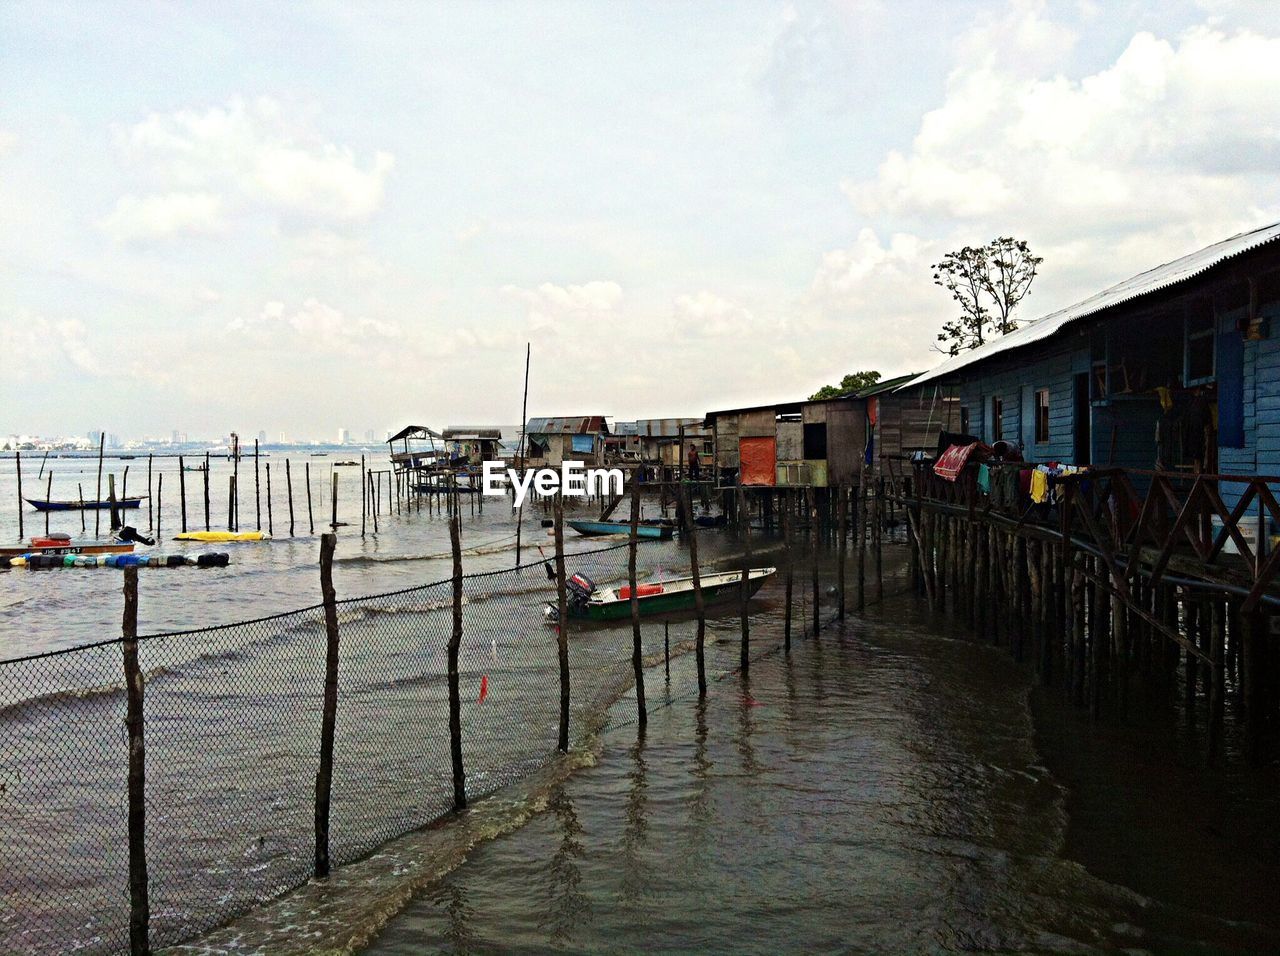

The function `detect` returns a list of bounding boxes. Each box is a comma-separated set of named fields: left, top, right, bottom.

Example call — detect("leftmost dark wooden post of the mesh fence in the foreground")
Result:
left=120, top=567, right=151, bottom=956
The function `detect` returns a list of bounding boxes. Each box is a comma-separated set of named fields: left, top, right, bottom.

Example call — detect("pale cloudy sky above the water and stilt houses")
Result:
left=0, top=0, right=1280, bottom=438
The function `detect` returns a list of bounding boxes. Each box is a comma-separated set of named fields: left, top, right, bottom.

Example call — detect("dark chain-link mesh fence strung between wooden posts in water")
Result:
left=0, top=519, right=839, bottom=953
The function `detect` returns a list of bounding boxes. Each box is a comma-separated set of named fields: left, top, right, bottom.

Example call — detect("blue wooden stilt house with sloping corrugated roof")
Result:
left=904, top=223, right=1280, bottom=506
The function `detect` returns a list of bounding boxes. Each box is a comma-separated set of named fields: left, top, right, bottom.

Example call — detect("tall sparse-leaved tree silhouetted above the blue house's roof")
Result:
left=933, top=235, right=1044, bottom=356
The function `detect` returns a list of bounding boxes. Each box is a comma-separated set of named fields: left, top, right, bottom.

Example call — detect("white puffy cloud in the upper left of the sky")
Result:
left=115, top=97, right=396, bottom=238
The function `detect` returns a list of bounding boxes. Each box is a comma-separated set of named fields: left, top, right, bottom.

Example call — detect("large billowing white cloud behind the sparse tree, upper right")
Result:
left=810, top=10, right=1280, bottom=378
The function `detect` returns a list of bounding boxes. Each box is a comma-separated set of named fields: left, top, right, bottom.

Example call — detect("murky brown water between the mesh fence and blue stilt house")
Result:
left=369, top=578, right=1280, bottom=953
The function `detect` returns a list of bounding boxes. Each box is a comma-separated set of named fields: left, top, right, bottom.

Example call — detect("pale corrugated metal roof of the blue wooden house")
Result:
left=901, top=223, right=1280, bottom=388
